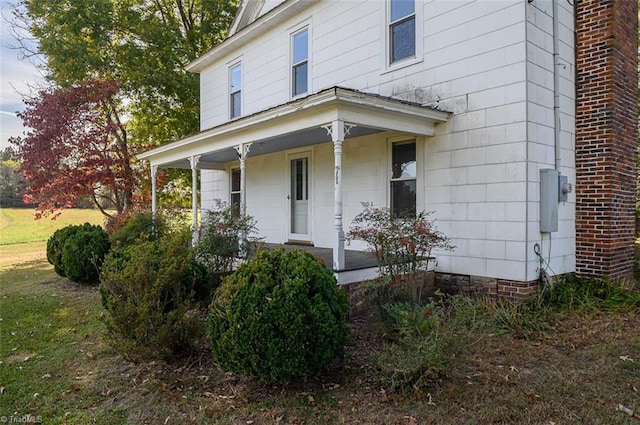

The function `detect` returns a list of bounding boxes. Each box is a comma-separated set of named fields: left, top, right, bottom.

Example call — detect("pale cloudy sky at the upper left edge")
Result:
left=0, top=0, right=42, bottom=149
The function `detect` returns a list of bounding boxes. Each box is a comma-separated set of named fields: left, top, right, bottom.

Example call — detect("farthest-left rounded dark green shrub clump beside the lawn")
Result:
left=47, top=223, right=111, bottom=283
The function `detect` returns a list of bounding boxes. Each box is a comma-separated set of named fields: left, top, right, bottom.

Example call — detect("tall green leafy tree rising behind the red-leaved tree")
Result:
left=8, top=0, right=238, bottom=209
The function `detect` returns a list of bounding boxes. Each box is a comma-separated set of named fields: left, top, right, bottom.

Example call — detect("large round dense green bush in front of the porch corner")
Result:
left=209, top=250, right=350, bottom=383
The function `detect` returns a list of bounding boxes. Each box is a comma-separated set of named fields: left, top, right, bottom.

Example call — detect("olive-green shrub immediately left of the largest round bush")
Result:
left=100, top=232, right=204, bottom=360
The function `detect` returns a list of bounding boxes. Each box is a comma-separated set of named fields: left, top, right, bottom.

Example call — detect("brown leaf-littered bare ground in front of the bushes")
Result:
left=86, top=304, right=640, bottom=425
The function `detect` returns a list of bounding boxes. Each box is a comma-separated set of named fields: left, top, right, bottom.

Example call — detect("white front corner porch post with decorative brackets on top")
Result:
left=322, top=120, right=355, bottom=271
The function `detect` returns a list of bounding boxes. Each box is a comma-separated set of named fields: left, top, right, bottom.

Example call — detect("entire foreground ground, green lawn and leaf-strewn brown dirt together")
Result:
left=0, top=210, right=640, bottom=425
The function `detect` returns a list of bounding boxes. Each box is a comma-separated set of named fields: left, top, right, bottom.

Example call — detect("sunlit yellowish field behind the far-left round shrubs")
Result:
left=0, top=208, right=104, bottom=245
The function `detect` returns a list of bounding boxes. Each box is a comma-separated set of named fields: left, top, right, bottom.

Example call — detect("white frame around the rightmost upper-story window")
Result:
left=381, top=0, right=425, bottom=74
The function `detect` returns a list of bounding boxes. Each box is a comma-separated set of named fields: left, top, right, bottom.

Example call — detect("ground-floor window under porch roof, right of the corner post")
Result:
left=389, top=141, right=417, bottom=217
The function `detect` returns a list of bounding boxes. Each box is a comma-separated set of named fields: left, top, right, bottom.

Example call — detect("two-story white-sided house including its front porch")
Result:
left=139, top=0, right=636, bottom=295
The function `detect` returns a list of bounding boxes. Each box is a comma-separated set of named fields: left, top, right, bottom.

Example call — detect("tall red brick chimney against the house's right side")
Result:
left=576, top=0, right=638, bottom=278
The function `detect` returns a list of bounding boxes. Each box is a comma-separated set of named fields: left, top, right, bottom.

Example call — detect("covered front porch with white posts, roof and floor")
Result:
left=138, top=87, right=450, bottom=274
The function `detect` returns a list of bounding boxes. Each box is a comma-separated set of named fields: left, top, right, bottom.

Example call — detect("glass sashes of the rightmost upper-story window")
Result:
left=389, top=0, right=416, bottom=63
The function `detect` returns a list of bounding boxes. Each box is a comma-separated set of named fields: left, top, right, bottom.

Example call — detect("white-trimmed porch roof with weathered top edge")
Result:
left=137, top=87, right=450, bottom=169
